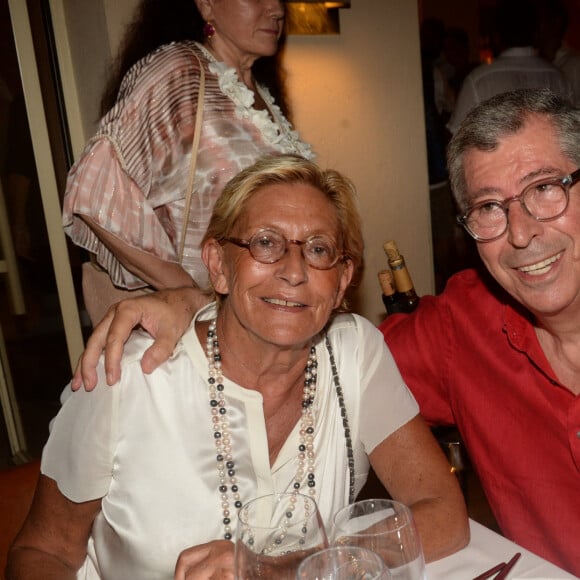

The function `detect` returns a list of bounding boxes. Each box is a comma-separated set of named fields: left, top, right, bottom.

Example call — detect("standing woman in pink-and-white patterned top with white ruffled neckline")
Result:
left=63, top=0, right=311, bottom=318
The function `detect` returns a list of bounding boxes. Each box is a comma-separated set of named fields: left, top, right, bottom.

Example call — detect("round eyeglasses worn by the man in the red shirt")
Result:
left=457, top=169, right=580, bottom=242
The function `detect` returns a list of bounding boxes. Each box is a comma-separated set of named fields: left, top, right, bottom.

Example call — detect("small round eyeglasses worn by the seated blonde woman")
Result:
left=223, top=230, right=346, bottom=270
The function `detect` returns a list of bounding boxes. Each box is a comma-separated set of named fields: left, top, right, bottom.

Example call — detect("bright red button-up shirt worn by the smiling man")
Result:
left=380, top=270, right=580, bottom=576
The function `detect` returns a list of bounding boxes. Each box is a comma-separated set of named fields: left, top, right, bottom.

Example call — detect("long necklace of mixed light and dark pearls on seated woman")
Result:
left=206, top=319, right=318, bottom=540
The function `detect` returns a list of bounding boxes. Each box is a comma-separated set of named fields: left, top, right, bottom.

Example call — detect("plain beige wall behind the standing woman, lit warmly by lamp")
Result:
left=61, top=0, right=434, bottom=322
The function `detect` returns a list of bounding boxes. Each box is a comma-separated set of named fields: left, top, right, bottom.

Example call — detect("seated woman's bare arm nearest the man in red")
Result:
left=369, top=415, right=469, bottom=561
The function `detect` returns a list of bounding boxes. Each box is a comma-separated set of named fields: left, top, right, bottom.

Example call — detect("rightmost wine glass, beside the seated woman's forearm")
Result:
left=332, top=499, right=425, bottom=580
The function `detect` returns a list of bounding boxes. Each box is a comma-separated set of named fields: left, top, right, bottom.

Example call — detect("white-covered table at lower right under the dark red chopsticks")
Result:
left=427, top=520, right=577, bottom=580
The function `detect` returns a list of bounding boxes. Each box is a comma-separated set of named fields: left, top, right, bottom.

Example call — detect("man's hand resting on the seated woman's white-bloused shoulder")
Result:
left=71, top=287, right=210, bottom=391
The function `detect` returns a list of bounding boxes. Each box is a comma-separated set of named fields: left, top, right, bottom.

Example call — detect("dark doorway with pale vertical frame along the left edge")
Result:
left=0, top=0, right=83, bottom=467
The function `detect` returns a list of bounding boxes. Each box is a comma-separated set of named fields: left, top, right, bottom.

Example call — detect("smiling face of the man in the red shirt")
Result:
left=464, top=116, right=580, bottom=317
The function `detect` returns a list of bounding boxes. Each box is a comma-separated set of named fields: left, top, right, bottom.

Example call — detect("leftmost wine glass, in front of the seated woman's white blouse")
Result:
left=235, top=493, right=328, bottom=580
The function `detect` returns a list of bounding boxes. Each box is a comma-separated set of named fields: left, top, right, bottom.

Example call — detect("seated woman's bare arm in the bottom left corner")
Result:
left=6, top=475, right=101, bottom=580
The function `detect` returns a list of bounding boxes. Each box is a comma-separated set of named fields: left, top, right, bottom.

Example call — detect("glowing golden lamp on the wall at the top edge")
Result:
left=285, top=0, right=350, bottom=34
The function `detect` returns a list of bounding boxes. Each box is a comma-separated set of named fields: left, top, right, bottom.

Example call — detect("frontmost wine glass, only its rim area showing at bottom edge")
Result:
left=296, top=546, right=391, bottom=580
